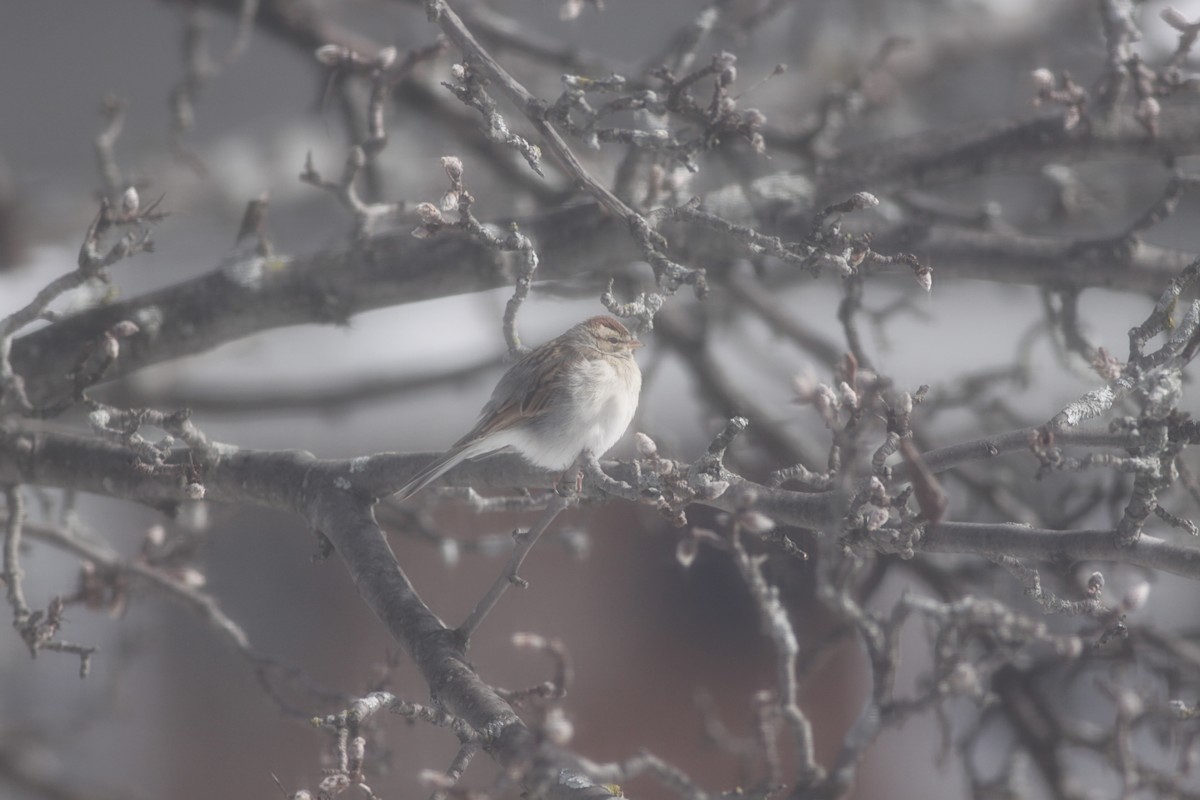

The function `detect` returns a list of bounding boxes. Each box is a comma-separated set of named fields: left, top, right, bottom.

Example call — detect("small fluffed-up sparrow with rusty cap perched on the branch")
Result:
left=394, top=317, right=642, bottom=500
